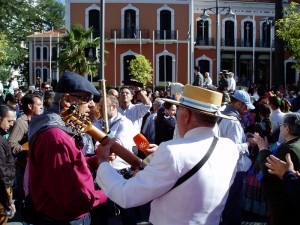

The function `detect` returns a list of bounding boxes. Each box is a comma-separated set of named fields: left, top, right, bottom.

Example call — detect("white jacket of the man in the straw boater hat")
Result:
left=96, top=127, right=239, bottom=225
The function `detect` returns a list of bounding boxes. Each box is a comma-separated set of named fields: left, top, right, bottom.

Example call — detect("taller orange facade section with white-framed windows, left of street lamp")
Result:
left=66, top=0, right=190, bottom=89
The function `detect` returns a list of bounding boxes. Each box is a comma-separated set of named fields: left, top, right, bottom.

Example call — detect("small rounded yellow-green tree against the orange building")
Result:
left=128, top=55, right=153, bottom=86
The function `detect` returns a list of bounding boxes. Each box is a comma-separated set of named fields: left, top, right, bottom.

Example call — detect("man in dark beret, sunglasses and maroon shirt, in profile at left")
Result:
left=28, top=72, right=107, bottom=225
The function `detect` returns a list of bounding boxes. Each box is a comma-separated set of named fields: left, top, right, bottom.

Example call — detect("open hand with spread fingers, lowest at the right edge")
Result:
left=266, top=154, right=295, bottom=179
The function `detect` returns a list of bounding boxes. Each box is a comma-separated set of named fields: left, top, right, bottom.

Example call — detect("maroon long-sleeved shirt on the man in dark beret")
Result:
left=28, top=128, right=107, bottom=221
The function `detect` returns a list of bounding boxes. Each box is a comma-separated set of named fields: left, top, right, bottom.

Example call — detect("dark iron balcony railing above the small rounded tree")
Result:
left=110, top=29, right=150, bottom=39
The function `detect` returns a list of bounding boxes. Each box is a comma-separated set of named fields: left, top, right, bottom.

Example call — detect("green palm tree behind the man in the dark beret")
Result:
left=58, top=24, right=99, bottom=76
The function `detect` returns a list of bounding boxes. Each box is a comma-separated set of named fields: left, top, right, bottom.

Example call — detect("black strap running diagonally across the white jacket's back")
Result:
left=170, top=136, right=218, bottom=191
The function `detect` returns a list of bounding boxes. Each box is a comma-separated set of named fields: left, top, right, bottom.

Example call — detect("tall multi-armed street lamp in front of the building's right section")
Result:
left=200, top=0, right=236, bottom=84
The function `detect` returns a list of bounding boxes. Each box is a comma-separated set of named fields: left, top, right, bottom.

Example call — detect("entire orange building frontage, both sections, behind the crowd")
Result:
left=30, top=0, right=299, bottom=90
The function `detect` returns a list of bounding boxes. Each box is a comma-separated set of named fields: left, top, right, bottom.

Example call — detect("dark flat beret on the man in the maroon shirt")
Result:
left=55, top=71, right=100, bottom=95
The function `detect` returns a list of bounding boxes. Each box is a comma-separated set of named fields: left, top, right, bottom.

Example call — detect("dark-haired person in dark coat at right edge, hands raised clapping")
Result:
left=254, top=113, right=300, bottom=225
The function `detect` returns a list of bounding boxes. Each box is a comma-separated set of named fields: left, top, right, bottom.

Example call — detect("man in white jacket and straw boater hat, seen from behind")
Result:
left=96, top=85, right=238, bottom=225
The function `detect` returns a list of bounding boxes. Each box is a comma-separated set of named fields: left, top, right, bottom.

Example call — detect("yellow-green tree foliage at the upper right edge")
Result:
left=275, top=2, right=300, bottom=68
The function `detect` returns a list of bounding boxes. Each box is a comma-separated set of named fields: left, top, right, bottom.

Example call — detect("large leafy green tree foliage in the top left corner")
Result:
left=0, top=0, right=64, bottom=82
